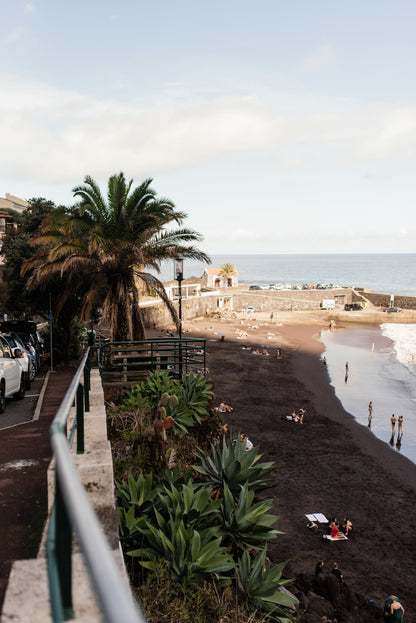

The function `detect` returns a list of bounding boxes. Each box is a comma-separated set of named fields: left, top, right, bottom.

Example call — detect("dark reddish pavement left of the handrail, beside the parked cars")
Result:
left=0, top=366, right=76, bottom=612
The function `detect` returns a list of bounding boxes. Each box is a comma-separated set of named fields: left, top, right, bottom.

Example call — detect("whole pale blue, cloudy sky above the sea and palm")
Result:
left=0, top=0, right=416, bottom=254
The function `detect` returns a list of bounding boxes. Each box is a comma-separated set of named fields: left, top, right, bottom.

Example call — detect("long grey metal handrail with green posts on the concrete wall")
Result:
left=46, top=349, right=146, bottom=623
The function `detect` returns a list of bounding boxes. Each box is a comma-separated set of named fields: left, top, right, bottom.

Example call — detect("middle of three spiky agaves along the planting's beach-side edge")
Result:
left=221, top=483, right=281, bottom=551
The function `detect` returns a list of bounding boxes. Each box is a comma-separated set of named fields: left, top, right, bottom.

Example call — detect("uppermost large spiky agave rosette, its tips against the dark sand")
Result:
left=194, top=435, right=274, bottom=498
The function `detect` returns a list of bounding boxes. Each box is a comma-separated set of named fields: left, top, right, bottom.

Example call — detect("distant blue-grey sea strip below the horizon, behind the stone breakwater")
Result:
left=154, top=254, right=416, bottom=296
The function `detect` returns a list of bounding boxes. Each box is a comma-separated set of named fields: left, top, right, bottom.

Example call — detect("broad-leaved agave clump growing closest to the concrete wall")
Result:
left=117, top=476, right=234, bottom=582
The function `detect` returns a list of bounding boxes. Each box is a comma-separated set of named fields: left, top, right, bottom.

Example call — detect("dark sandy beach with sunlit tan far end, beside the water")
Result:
left=176, top=313, right=416, bottom=621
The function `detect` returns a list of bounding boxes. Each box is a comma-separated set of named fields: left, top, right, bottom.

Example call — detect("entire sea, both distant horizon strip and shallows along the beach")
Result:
left=153, top=254, right=416, bottom=463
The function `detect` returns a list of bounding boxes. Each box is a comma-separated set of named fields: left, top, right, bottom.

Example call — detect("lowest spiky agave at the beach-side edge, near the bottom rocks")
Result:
left=236, top=547, right=298, bottom=623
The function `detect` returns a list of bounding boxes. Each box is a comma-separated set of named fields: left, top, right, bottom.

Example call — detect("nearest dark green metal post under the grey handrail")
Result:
left=55, top=476, right=73, bottom=621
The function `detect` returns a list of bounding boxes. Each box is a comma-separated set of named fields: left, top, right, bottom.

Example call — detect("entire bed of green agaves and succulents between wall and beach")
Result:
left=112, top=371, right=296, bottom=623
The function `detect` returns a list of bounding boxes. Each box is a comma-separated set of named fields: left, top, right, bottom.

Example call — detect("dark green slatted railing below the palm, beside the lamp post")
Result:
left=99, top=338, right=206, bottom=382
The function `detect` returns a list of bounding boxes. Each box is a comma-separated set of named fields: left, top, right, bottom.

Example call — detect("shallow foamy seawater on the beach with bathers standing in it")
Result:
left=321, top=323, right=416, bottom=463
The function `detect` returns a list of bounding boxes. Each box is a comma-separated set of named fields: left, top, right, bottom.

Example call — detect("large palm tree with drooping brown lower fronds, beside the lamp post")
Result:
left=23, top=173, right=210, bottom=341
